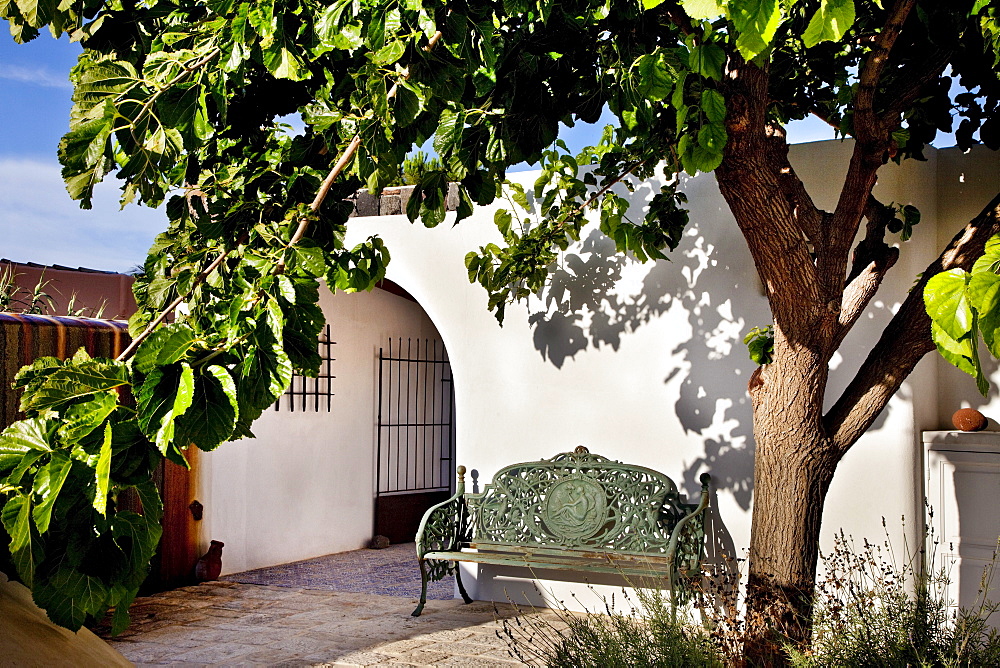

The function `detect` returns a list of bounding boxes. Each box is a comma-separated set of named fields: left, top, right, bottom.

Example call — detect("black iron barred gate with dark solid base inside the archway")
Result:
left=375, top=338, right=455, bottom=543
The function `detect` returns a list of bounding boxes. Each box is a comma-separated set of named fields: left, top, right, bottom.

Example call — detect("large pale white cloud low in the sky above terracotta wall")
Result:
left=0, top=158, right=167, bottom=271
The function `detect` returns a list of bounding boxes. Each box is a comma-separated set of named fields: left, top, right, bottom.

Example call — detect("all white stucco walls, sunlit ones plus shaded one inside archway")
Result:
left=200, top=142, right=1000, bottom=607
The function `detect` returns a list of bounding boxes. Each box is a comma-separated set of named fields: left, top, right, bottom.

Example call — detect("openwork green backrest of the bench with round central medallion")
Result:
left=465, top=446, right=700, bottom=553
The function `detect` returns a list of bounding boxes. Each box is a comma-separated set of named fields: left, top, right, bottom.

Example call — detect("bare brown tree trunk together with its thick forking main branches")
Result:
left=716, top=64, right=1000, bottom=665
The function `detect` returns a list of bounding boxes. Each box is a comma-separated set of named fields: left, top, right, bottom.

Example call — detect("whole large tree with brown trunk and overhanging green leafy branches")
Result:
left=0, top=0, right=1000, bottom=660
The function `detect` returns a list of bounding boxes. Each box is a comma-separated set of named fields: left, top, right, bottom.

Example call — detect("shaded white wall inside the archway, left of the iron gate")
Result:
left=198, top=289, right=440, bottom=574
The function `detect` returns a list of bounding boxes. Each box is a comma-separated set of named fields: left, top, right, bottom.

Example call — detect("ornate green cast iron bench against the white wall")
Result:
left=413, top=445, right=711, bottom=617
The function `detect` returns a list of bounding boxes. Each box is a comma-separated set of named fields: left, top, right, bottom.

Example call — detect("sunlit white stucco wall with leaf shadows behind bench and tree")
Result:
left=334, top=142, right=997, bottom=600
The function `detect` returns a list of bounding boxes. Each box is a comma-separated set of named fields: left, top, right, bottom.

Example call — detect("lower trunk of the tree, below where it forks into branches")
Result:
left=745, top=342, right=838, bottom=666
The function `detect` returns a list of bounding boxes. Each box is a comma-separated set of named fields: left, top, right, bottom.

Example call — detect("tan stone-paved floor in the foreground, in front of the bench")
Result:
left=98, top=582, right=559, bottom=668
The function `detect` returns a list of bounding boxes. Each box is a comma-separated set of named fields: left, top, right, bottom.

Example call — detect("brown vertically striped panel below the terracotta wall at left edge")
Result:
left=0, top=313, right=130, bottom=429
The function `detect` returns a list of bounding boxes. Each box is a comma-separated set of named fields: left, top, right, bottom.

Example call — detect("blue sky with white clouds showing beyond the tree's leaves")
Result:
left=0, top=33, right=852, bottom=271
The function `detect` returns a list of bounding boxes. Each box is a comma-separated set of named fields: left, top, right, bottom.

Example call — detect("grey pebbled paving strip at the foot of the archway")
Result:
left=222, top=543, right=455, bottom=601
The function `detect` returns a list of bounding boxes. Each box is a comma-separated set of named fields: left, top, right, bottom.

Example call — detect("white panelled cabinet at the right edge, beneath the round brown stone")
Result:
left=924, top=431, right=1000, bottom=627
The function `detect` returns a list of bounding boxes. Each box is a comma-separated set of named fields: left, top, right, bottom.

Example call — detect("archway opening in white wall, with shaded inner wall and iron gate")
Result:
left=184, top=281, right=454, bottom=575
